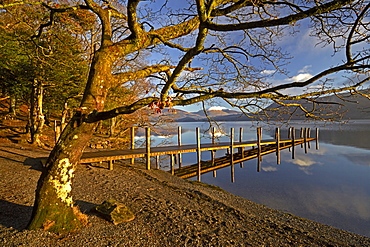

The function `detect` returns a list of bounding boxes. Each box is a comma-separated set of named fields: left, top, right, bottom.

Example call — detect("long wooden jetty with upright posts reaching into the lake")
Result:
left=80, top=127, right=318, bottom=180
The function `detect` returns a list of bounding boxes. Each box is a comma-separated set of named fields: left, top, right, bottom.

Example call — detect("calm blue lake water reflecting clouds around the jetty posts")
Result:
left=138, top=120, right=370, bottom=237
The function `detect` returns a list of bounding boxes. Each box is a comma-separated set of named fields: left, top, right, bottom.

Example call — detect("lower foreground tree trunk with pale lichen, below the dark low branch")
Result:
left=28, top=117, right=96, bottom=233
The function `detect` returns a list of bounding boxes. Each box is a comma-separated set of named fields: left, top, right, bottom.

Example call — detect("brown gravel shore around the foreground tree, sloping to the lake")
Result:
left=0, top=143, right=370, bottom=247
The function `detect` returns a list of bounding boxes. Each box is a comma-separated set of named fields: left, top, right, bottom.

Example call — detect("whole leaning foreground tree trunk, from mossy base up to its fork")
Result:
left=28, top=50, right=112, bottom=233
